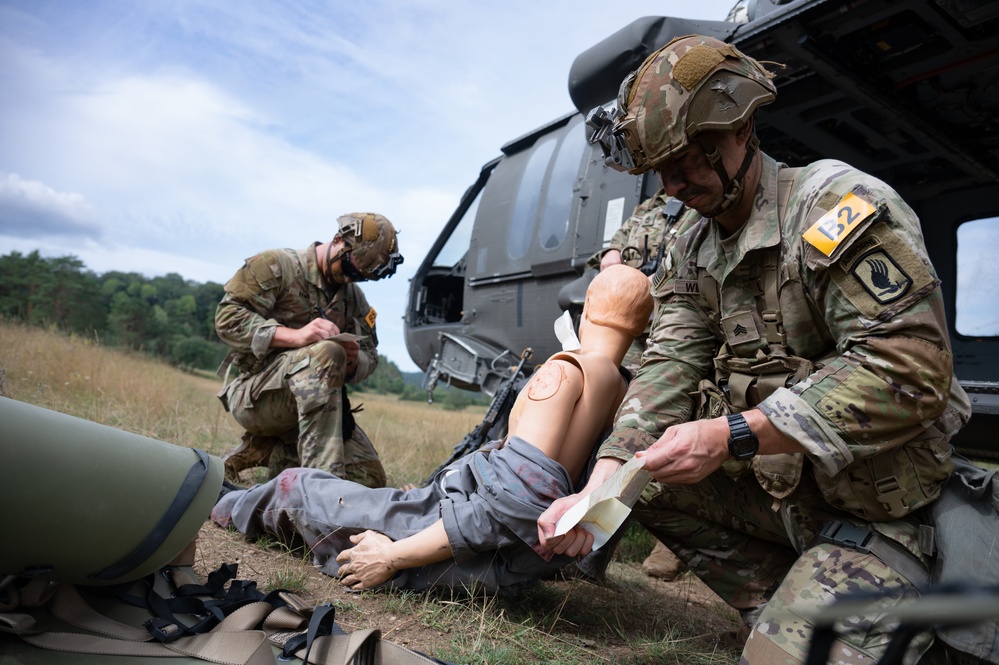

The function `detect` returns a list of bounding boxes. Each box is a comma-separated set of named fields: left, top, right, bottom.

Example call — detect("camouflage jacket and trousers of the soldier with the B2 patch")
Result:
left=599, top=155, right=970, bottom=663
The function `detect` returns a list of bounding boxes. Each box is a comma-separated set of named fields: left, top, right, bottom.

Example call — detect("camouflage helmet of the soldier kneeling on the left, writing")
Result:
left=332, top=212, right=403, bottom=282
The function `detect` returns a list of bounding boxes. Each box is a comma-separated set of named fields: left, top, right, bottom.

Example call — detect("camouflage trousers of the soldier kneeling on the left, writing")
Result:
left=222, top=341, right=386, bottom=487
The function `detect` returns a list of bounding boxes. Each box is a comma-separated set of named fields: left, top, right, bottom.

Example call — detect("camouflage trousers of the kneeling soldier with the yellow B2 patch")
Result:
left=633, top=471, right=932, bottom=665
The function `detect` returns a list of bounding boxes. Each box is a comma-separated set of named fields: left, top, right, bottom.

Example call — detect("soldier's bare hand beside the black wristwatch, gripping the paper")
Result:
left=635, top=418, right=728, bottom=485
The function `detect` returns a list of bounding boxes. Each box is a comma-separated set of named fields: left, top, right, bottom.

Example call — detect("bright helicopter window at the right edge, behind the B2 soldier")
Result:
left=954, top=217, right=999, bottom=337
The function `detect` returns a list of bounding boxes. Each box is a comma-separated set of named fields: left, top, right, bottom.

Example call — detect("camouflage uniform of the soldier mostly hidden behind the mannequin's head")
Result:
left=586, top=188, right=685, bottom=373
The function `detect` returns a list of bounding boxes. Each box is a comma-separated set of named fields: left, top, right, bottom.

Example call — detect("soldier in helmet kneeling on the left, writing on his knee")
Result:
left=215, top=213, right=402, bottom=487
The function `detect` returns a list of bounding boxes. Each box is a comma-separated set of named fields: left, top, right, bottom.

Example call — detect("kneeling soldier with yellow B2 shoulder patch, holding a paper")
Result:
left=538, top=35, right=970, bottom=663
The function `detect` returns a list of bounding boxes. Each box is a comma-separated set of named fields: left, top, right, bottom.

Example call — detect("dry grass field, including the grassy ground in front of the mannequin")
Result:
left=0, top=322, right=740, bottom=665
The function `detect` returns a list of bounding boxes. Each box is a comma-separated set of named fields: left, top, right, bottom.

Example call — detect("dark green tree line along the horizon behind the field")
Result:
left=0, top=251, right=488, bottom=408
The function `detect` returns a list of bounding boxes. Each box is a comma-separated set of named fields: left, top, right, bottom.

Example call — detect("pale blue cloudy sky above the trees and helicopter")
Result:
left=0, top=0, right=734, bottom=371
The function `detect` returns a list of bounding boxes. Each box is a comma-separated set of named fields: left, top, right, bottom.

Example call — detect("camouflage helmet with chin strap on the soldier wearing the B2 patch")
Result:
left=611, top=35, right=777, bottom=217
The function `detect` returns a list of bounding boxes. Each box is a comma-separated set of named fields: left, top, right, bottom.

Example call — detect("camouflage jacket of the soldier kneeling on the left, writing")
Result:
left=215, top=243, right=378, bottom=383
